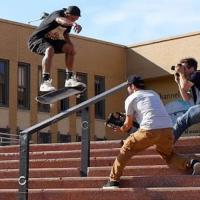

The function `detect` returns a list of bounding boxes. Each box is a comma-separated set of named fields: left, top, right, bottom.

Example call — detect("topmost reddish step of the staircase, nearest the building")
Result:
left=0, top=136, right=200, bottom=153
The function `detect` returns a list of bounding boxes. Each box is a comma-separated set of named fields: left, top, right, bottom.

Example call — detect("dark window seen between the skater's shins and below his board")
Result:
left=58, top=69, right=69, bottom=111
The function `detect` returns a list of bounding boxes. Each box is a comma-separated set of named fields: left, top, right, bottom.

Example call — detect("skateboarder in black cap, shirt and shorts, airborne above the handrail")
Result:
left=28, top=6, right=84, bottom=92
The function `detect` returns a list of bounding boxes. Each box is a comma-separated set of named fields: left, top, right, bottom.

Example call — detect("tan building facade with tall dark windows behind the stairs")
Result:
left=0, top=19, right=200, bottom=143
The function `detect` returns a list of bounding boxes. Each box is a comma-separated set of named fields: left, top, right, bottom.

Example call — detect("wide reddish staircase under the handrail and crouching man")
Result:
left=0, top=137, right=200, bottom=200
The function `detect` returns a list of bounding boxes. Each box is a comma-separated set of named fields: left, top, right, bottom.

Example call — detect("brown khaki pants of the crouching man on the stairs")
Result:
left=110, top=128, right=190, bottom=181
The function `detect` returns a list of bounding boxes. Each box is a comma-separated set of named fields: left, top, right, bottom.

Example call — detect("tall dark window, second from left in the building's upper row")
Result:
left=18, top=63, right=30, bottom=109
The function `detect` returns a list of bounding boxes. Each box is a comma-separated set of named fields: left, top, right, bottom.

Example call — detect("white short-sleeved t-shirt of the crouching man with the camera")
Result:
left=125, top=90, right=172, bottom=130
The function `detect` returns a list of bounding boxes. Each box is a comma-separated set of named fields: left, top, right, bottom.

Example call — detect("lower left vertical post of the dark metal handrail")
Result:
left=18, top=133, right=30, bottom=200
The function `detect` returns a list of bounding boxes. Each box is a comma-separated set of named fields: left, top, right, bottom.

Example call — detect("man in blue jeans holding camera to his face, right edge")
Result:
left=172, top=58, right=200, bottom=141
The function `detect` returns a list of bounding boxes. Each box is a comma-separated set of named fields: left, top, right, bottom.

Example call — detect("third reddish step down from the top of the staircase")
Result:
left=0, top=154, right=200, bottom=169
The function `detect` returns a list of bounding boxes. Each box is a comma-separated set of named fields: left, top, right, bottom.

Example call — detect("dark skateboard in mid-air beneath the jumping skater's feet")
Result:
left=35, top=85, right=86, bottom=104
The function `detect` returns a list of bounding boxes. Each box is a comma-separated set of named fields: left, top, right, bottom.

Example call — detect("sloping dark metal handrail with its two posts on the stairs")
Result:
left=18, top=82, right=127, bottom=200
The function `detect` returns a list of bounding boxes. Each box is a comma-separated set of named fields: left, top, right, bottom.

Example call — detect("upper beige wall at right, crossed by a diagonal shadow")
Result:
left=127, top=33, right=200, bottom=78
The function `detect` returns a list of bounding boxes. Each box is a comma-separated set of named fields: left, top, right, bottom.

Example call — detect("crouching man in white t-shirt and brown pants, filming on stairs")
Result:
left=103, top=75, right=200, bottom=189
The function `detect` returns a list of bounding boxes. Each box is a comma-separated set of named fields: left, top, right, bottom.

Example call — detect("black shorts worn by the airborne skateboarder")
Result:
left=28, top=36, right=66, bottom=55
